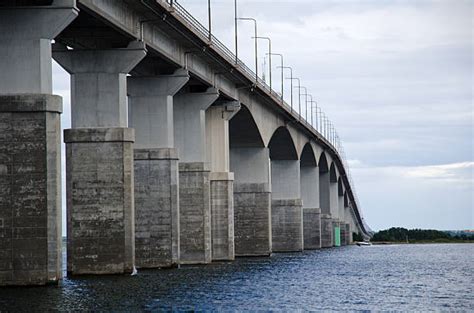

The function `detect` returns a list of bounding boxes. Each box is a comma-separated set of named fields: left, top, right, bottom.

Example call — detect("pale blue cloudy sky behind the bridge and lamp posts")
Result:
left=53, top=0, right=474, bottom=230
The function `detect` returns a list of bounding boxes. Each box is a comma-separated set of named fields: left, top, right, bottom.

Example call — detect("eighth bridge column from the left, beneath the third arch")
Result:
left=300, top=162, right=321, bottom=250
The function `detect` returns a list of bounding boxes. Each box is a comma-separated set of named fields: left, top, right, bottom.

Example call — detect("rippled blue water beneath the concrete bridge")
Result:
left=0, top=244, right=474, bottom=312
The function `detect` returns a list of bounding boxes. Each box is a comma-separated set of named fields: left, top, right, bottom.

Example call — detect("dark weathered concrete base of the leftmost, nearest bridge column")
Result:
left=0, top=94, right=62, bottom=286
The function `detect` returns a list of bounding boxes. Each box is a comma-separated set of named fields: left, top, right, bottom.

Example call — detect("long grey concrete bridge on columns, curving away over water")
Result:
left=0, top=0, right=370, bottom=285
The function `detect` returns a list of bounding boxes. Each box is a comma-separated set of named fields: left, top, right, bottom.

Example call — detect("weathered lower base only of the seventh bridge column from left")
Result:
left=272, top=199, right=303, bottom=252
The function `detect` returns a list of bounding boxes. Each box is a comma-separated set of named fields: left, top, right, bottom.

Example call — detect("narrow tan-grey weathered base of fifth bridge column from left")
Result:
left=210, top=172, right=235, bottom=261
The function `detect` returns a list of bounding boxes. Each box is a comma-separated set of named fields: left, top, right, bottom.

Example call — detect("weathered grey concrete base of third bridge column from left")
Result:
left=134, top=148, right=179, bottom=268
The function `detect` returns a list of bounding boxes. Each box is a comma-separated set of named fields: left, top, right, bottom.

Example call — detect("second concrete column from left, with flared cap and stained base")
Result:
left=53, top=42, right=146, bottom=275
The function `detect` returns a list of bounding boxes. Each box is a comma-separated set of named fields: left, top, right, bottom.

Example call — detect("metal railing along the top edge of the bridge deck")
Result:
left=166, top=0, right=370, bottom=231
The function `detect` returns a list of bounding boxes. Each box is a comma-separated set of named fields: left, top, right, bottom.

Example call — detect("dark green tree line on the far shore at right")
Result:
left=371, top=227, right=474, bottom=242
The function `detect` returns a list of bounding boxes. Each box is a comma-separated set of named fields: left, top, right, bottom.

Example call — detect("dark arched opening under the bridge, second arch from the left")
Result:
left=268, top=126, right=299, bottom=160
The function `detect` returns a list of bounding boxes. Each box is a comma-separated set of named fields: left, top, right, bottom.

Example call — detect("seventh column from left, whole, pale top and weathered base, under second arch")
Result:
left=271, top=160, right=303, bottom=252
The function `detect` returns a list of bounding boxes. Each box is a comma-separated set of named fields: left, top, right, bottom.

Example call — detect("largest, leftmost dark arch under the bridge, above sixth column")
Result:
left=229, top=105, right=265, bottom=148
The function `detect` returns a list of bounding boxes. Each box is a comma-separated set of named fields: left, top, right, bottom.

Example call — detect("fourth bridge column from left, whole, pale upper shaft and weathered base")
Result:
left=174, top=88, right=219, bottom=264
